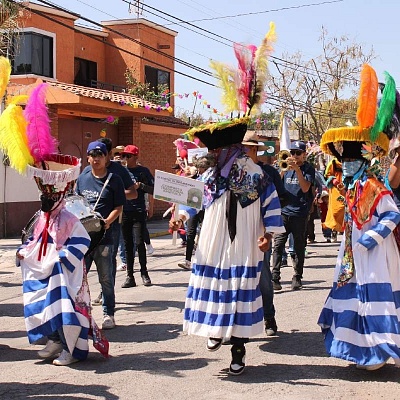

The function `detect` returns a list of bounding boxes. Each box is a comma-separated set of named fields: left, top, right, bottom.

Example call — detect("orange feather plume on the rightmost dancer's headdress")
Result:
left=357, top=64, right=379, bottom=128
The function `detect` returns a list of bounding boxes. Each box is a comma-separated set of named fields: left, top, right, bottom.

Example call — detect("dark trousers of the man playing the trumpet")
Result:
left=272, top=214, right=308, bottom=281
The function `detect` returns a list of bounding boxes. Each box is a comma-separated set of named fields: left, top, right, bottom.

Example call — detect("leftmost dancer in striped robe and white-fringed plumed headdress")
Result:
left=0, top=57, right=108, bottom=365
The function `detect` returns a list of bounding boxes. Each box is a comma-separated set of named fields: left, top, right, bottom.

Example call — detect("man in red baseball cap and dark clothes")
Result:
left=122, top=144, right=154, bottom=288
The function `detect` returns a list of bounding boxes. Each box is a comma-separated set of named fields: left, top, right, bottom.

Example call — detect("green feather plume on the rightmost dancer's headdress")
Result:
left=370, top=71, right=396, bottom=142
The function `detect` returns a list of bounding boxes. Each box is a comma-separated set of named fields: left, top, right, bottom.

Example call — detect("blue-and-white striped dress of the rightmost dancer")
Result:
left=318, top=195, right=400, bottom=366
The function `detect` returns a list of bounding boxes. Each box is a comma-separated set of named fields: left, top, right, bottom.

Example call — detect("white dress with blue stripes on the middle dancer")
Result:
left=183, top=157, right=284, bottom=338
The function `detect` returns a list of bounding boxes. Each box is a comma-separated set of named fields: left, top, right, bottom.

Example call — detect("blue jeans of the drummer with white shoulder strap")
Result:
left=85, top=245, right=115, bottom=316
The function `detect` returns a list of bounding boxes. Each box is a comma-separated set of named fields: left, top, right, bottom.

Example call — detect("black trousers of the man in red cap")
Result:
left=122, top=211, right=147, bottom=277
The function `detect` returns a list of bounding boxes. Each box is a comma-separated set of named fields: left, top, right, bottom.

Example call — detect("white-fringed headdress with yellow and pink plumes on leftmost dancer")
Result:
left=0, top=57, right=81, bottom=194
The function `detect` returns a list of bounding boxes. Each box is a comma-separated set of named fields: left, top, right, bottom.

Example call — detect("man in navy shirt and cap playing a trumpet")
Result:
left=272, top=141, right=315, bottom=290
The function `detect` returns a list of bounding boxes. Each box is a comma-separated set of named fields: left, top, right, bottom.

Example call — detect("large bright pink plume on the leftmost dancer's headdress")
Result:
left=24, top=83, right=57, bottom=164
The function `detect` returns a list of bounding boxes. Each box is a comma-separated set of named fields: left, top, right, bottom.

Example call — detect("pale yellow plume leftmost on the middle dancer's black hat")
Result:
left=210, top=60, right=239, bottom=112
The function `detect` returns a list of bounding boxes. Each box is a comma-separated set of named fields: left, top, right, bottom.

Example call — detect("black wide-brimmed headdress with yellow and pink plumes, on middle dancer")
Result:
left=186, top=22, right=276, bottom=149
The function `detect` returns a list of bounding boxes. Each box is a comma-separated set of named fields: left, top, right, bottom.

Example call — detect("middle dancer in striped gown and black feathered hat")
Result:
left=170, top=24, right=283, bottom=375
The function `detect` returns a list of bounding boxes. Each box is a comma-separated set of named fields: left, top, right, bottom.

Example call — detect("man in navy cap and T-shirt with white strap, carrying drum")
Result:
left=76, top=141, right=125, bottom=329
